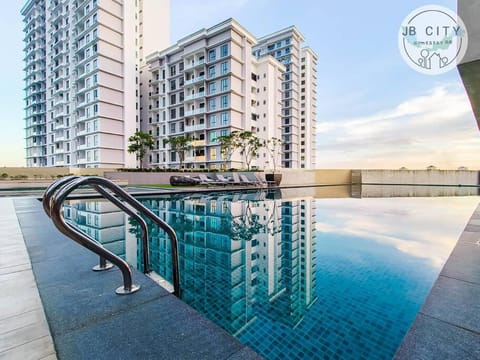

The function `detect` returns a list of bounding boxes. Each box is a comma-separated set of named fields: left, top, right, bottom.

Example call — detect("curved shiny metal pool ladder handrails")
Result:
left=42, top=176, right=180, bottom=296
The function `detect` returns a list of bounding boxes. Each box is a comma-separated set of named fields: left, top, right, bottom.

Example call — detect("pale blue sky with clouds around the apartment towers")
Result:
left=0, top=0, right=480, bottom=169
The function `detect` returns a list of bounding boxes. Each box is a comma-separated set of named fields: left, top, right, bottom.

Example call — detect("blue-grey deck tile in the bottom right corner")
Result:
left=395, top=314, right=480, bottom=360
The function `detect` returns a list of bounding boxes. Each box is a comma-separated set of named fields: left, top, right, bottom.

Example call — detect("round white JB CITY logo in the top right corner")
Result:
left=398, top=5, right=468, bottom=75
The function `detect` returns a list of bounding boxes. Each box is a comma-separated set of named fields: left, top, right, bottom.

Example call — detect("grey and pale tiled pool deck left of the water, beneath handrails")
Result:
left=0, top=198, right=261, bottom=360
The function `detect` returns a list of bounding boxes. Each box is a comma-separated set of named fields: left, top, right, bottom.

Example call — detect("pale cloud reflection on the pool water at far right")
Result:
left=315, top=196, right=478, bottom=268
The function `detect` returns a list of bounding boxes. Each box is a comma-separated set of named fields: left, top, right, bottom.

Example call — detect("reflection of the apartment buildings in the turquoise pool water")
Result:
left=64, top=191, right=316, bottom=336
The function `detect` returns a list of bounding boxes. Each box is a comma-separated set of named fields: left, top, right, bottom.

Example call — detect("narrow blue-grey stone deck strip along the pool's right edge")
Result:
left=395, top=205, right=480, bottom=360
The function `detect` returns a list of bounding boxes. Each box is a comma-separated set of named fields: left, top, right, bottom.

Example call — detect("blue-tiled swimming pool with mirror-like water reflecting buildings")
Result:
left=65, top=187, right=479, bottom=359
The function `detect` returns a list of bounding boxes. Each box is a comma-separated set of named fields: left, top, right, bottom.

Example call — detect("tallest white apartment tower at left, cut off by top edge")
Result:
left=21, top=0, right=169, bottom=168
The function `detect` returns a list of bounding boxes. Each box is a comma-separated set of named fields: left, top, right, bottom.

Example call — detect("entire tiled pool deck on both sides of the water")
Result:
left=0, top=197, right=480, bottom=360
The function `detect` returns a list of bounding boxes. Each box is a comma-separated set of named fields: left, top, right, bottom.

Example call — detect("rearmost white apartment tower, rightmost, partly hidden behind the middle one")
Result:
left=253, top=26, right=317, bottom=169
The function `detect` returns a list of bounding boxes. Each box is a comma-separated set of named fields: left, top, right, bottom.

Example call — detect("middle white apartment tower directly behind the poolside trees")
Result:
left=141, top=19, right=285, bottom=169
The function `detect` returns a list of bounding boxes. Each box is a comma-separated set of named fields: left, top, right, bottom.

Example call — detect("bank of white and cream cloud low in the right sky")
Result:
left=317, top=85, right=480, bottom=168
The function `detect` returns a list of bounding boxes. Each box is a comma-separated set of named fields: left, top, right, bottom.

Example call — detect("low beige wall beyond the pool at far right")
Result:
left=358, top=170, right=479, bottom=185
